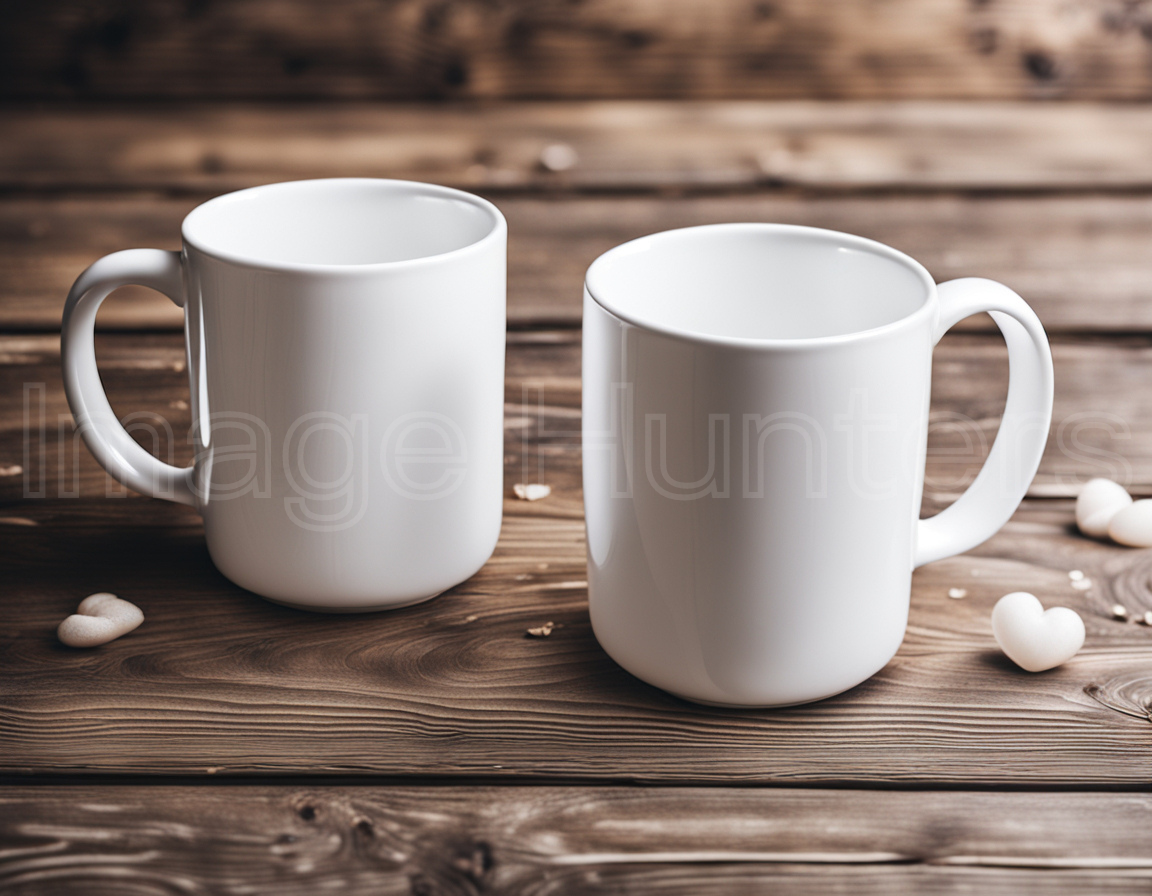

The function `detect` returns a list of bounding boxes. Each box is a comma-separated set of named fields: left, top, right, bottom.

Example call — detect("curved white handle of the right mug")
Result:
left=915, top=278, right=1053, bottom=567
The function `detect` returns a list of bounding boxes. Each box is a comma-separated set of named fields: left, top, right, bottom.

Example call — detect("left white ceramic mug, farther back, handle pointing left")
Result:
left=62, top=179, right=507, bottom=610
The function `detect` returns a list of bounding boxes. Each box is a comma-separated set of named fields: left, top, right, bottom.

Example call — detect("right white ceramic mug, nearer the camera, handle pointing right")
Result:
left=583, top=223, right=1053, bottom=706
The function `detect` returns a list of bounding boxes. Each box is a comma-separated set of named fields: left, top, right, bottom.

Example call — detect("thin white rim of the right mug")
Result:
left=584, top=221, right=937, bottom=349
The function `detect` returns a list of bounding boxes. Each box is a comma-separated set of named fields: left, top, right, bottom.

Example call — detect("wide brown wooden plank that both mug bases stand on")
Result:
left=0, top=488, right=1152, bottom=789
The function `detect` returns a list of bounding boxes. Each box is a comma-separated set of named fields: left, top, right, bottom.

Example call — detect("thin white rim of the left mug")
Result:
left=180, top=177, right=508, bottom=275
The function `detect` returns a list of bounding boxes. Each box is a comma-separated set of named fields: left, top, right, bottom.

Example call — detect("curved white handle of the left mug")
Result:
left=60, top=249, right=197, bottom=507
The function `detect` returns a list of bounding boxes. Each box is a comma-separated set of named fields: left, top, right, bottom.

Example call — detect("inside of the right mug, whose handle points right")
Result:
left=586, top=223, right=934, bottom=341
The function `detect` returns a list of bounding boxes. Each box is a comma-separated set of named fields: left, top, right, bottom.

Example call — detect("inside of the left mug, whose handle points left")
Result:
left=183, top=179, right=501, bottom=267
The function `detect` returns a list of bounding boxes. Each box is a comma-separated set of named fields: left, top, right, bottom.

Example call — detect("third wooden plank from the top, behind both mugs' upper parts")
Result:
left=0, top=193, right=1152, bottom=333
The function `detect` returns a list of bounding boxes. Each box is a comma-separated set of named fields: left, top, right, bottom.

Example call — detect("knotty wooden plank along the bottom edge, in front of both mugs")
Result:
left=0, top=784, right=1152, bottom=896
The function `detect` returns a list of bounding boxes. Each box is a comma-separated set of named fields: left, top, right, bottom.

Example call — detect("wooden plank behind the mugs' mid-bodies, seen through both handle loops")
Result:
left=0, top=331, right=1152, bottom=506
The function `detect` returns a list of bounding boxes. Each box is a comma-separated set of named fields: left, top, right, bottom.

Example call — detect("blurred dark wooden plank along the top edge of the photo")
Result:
left=0, top=0, right=1152, bottom=99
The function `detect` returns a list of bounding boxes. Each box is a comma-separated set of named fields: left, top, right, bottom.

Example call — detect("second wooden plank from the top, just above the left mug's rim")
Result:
left=11, top=101, right=1152, bottom=192
